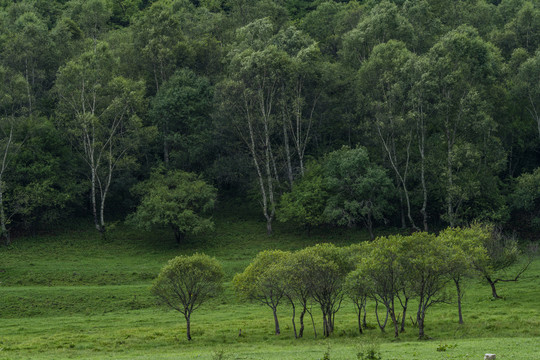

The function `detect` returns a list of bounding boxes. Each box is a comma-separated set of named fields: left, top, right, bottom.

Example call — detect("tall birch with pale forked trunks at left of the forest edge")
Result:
left=56, top=42, right=148, bottom=234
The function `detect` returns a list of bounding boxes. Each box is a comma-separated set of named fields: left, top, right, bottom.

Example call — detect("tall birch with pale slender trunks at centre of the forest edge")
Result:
left=221, top=19, right=289, bottom=235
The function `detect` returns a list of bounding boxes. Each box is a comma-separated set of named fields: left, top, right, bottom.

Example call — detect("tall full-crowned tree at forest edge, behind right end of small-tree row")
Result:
left=422, top=26, right=504, bottom=226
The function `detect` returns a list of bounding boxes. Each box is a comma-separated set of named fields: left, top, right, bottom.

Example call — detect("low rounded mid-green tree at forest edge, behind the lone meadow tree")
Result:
left=128, top=168, right=216, bottom=244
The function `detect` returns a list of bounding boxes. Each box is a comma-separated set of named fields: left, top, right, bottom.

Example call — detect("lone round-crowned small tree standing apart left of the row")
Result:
left=151, top=254, right=223, bottom=340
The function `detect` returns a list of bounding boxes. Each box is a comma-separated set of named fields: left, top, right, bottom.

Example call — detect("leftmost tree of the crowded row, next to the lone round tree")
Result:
left=233, top=250, right=290, bottom=335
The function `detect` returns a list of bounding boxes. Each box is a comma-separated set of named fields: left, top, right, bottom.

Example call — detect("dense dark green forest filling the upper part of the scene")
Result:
left=0, top=0, right=540, bottom=243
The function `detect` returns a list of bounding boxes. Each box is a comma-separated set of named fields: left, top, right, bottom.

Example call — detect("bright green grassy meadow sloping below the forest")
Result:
left=0, top=208, right=540, bottom=360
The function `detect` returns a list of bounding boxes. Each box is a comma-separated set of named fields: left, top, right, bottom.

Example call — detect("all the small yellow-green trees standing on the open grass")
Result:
left=153, top=225, right=532, bottom=339
